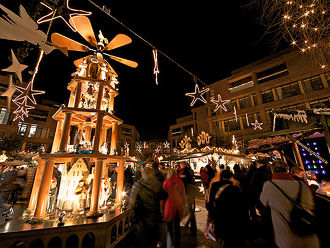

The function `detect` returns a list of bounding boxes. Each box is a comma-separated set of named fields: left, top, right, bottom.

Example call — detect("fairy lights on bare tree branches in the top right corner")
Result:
left=251, top=0, right=330, bottom=69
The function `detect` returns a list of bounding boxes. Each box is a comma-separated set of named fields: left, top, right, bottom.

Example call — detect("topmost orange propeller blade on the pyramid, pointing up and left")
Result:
left=70, top=16, right=97, bottom=46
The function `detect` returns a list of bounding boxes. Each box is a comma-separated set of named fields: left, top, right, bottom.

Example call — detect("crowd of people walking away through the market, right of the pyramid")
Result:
left=129, top=160, right=320, bottom=248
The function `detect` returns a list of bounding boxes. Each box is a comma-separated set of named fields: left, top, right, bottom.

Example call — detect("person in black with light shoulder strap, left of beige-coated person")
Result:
left=209, top=170, right=249, bottom=248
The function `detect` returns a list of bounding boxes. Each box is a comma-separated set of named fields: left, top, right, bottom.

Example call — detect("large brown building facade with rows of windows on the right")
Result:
left=169, top=49, right=330, bottom=146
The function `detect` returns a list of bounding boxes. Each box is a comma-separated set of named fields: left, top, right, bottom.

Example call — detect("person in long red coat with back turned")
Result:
left=163, top=169, right=186, bottom=248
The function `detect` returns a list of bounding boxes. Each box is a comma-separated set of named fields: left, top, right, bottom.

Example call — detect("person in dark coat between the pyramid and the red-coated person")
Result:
left=129, top=167, right=167, bottom=248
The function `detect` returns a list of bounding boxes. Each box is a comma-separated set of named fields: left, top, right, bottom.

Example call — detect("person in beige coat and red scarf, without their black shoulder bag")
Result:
left=260, top=161, right=320, bottom=248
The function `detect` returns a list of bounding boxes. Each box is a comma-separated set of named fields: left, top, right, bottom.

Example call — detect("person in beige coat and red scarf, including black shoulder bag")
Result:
left=260, top=161, right=320, bottom=248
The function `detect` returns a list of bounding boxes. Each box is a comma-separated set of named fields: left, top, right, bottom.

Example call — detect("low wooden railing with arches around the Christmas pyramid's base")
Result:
left=0, top=209, right=132, bottom=248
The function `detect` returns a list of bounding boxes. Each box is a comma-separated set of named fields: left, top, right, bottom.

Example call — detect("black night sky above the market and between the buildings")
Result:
left=1, top=0, right=284, bottom=140
